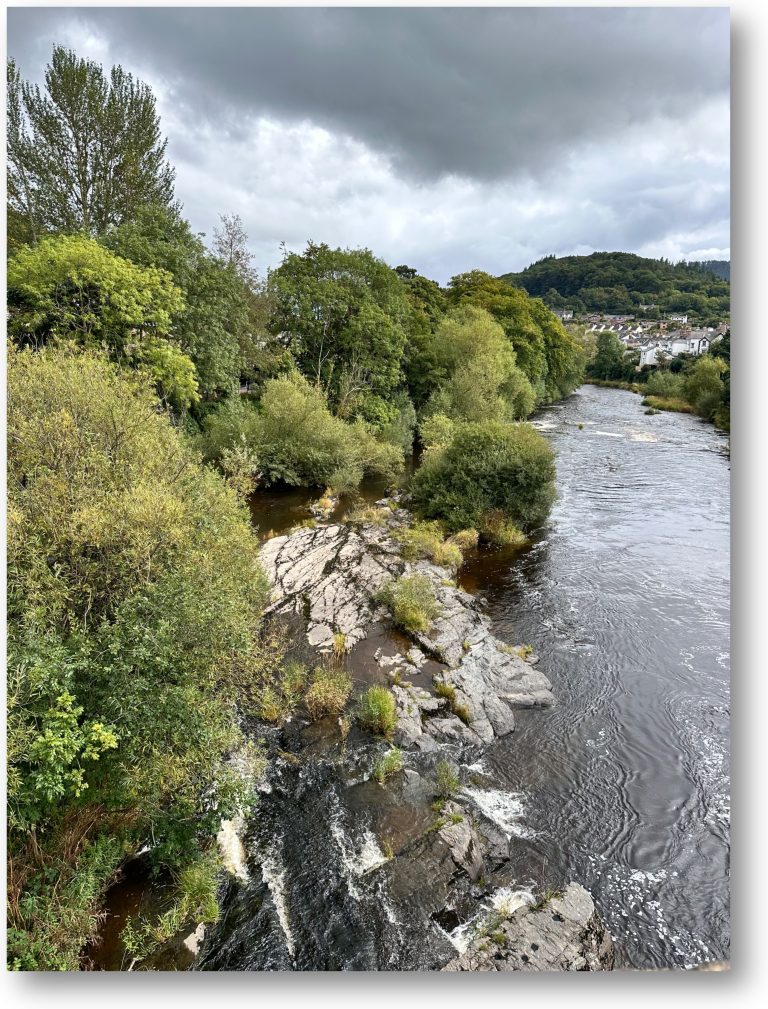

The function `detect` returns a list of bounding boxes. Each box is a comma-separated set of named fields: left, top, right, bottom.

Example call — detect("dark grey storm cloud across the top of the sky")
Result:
left=9, top=8, right=729, bottom=180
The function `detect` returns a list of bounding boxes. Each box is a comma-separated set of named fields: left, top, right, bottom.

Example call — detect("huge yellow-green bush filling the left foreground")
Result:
left=8, top=348, right=267, bottom=969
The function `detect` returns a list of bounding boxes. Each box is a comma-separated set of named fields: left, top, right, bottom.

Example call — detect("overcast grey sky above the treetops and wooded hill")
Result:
left=8, top=7, right=730, bottom=283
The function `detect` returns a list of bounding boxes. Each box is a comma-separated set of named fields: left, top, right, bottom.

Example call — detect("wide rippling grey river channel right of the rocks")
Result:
left=463, top=385, right=730, bottom=968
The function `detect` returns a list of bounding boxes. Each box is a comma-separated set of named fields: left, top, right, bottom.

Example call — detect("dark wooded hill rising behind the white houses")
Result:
left=502, top=252, right=731, bottom=319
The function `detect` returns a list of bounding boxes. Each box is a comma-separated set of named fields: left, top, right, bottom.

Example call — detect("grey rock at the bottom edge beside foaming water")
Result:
left=443, top=883, right=615, bottom=971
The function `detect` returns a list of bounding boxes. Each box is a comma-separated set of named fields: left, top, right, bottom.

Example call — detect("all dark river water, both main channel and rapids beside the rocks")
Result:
left=194, top=385, right=730, bottom=971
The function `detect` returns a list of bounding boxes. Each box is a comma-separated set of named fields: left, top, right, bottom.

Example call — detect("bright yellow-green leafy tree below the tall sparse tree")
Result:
left=8, top=235, right=198, bottom=410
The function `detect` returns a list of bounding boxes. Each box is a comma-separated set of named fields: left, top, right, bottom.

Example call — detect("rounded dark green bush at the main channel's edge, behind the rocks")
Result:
left=411, top=422, right=555, bottom=533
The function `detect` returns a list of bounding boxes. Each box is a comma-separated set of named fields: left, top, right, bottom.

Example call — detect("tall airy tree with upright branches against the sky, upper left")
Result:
left=7, top=45, right=174, bottom=240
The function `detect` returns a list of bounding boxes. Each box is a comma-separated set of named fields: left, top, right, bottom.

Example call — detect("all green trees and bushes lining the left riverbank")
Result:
left=7, top=47, right=589, bottom=970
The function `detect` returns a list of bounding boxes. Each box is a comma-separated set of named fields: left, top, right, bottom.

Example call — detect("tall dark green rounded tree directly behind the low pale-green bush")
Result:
left=270, top=242, right=410, bottom=426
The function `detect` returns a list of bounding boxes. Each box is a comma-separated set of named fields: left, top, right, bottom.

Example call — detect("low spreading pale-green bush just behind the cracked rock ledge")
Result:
left=197, top=373, right=403, bottom=491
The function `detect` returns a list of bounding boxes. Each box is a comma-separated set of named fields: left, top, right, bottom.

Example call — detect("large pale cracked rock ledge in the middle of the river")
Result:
left=260, top=499, right=554, bottom=751
